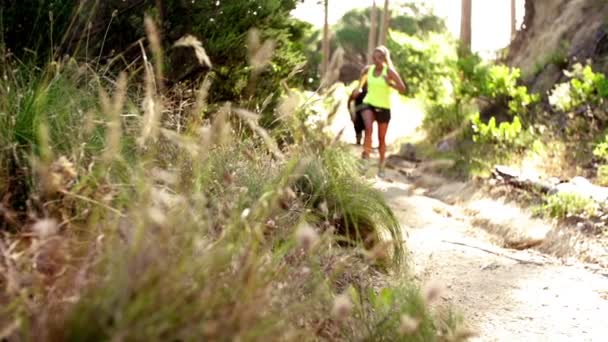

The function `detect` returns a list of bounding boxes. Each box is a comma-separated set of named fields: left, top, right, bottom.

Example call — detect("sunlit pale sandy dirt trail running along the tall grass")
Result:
left=376, top=163, right=608, bottom=341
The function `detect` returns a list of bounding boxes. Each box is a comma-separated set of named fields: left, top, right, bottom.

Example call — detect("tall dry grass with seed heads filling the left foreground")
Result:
left=0, top=15, right=470, bottom=341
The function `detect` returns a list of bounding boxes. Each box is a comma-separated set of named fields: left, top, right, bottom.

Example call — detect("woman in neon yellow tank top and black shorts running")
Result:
left=359, top=46, right=406, bottom=177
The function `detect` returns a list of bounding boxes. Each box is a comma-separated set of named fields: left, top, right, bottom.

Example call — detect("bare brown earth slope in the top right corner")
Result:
left=507, top=0, right=608, bottom=94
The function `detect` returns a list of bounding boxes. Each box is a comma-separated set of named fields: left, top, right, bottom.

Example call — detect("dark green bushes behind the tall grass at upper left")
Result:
left=0, top=0, right=316, bottom=115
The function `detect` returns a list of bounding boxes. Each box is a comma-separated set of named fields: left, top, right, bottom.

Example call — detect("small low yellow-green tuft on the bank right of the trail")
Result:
left=537, top=193, right=597, bottom=219
